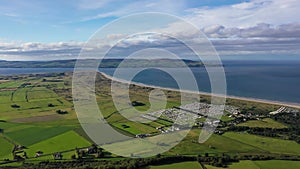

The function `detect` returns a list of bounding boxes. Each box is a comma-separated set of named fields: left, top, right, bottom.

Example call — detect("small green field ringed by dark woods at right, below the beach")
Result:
left=238, top=118, right=287, bottom=128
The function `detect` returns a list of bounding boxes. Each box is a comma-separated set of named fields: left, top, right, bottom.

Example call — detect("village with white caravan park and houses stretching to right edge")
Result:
left=136, top=102, right=299, bottom=138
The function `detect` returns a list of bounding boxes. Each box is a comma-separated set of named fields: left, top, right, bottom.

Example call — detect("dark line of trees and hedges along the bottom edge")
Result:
left=7, top=152, right=300, bottom=169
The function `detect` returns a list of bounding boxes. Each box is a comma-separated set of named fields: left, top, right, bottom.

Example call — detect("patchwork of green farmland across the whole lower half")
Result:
left=0, top=73, right=300, bottom=169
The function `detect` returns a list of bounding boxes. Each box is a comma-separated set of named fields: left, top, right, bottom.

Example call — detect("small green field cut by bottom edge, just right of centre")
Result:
left=147, top=162, right=202, bottom=169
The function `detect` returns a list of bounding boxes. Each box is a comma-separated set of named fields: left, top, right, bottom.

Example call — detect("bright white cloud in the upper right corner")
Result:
left=185, top=0, right=300, bottom=28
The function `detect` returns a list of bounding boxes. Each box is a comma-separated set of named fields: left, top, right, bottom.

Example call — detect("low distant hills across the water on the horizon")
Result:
left=0, top=59, right=207, bottom=68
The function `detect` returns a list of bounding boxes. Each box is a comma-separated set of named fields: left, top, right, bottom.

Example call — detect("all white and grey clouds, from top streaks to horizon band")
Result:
left=0, top=0, right=300, bottom=60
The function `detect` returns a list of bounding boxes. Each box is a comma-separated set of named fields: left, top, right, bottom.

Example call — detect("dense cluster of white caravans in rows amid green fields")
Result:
left=136, top=102, right=240, bottom=138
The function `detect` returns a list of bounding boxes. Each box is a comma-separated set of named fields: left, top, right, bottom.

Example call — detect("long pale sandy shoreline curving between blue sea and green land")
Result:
left=99, top=71, right=300, bottom=109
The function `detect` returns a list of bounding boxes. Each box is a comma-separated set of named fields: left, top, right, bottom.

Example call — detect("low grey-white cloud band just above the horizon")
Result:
left=0, top=23, right=300, bottom=60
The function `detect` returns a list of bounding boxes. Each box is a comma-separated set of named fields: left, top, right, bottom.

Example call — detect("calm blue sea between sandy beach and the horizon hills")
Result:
left=0, top=61, right=300, bottom=103
